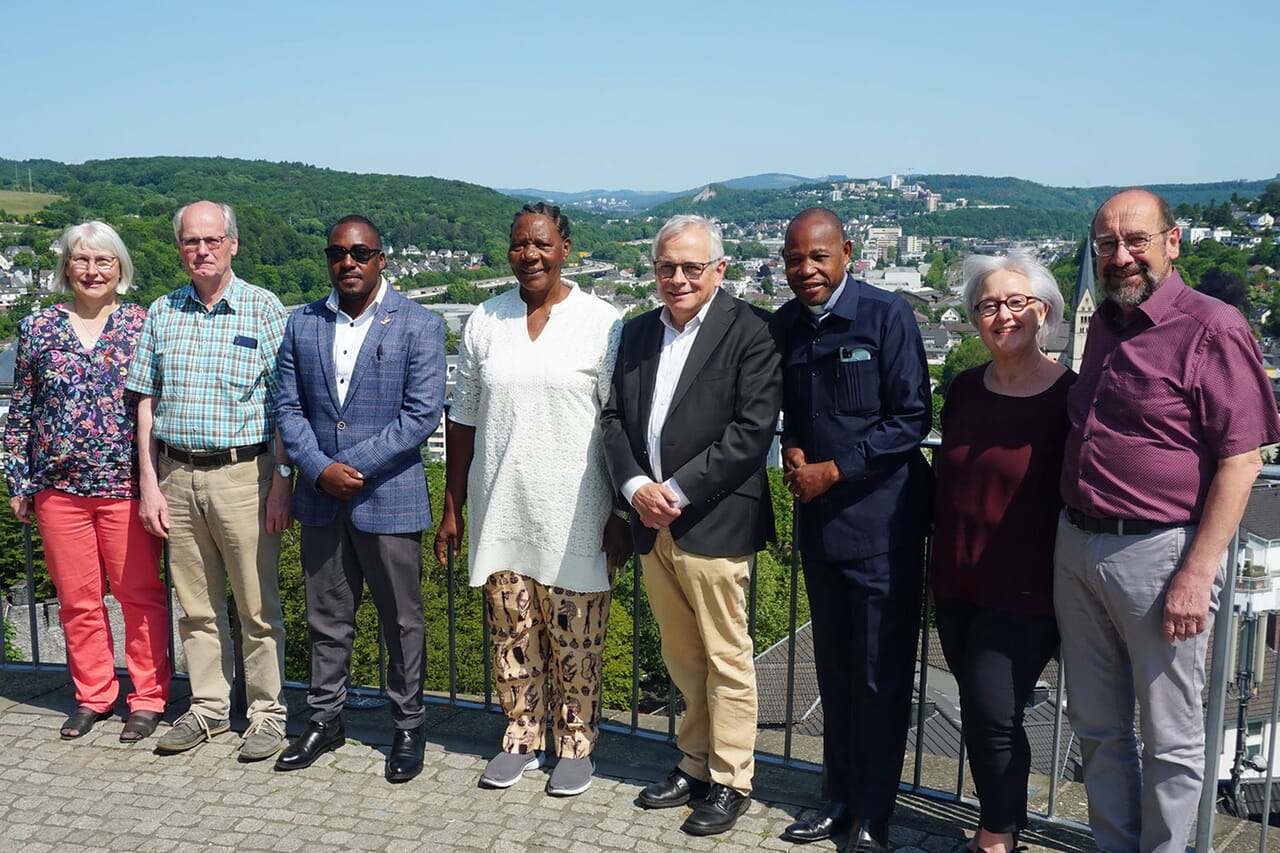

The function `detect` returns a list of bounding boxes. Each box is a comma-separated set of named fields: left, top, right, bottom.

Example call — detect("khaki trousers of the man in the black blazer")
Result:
left=640, top=529, right=756, bottom=794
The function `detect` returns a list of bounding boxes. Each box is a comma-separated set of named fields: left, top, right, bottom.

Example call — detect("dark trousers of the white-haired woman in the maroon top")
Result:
left=934, top=599, right=1057, bottom=833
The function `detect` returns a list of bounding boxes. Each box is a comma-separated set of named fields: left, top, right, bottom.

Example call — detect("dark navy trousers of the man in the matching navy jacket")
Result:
left=803, top=543, right=924, bottom=825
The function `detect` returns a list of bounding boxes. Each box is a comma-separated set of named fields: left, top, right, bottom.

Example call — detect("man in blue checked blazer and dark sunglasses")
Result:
left=275, top=216, right=445, bottom=783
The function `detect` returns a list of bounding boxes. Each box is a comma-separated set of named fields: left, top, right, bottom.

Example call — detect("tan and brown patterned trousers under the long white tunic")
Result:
left=484, top=571, right=611, bottom=758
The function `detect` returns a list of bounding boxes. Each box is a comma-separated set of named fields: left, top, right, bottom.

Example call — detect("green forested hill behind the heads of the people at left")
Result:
left=0, top=158, right=653, bottom=304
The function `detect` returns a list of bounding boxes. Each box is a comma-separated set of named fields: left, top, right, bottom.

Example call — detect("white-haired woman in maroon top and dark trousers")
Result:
left=929, top=252, right=1075, bottom=853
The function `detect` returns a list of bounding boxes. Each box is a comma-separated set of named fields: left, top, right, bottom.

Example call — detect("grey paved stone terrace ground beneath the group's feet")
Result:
left=0, top=670, right=1257, bottom=853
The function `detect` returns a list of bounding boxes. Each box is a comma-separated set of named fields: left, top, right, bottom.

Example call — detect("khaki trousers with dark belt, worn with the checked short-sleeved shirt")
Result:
left=159, top=453, right=288, bottom=721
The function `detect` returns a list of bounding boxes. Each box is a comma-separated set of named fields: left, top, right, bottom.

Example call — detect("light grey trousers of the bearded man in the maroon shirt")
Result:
left=1053, top=512, right=1225, bottom=853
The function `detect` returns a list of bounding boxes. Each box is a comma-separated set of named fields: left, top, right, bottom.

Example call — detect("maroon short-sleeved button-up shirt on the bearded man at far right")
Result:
left=1062, top=272, right=1280, bottom=524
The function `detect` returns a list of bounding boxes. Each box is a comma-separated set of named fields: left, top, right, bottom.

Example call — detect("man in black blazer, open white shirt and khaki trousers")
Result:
left=600, top=215, right=782, bottom=835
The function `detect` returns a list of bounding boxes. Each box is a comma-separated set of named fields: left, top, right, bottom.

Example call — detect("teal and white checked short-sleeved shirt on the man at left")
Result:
left=127, top=278, right=285, bottom=453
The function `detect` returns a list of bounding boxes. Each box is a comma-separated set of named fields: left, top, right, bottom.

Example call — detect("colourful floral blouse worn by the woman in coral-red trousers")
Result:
left=4, top=304, right=147, bottom=498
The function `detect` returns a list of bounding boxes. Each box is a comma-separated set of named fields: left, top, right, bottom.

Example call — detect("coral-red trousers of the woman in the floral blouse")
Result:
left=35, top=489, right=169, bottom=712
